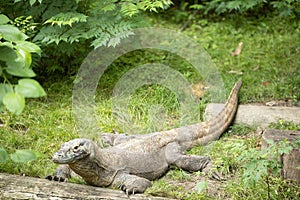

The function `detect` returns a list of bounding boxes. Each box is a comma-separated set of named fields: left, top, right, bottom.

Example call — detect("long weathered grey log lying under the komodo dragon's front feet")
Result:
left=0, top=174, right=172, bottom=200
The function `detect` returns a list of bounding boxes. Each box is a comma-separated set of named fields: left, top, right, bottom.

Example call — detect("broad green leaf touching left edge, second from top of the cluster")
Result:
left=0, top=25, right=28, bottom=42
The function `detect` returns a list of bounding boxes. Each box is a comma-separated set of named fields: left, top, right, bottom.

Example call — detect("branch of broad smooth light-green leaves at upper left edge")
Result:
left=0, top=15, right=46, bottom=115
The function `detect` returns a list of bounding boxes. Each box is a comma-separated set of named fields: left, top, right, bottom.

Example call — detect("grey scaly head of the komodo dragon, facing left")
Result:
left=52, top=139, right=93, bottom=164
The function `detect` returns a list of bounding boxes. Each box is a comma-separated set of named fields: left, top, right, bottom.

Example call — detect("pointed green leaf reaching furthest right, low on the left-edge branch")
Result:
left=15, top=79, right=46, bottom=98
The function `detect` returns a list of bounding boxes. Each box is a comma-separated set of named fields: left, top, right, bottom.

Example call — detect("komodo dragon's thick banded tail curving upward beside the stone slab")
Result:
left=176, top=79, right=242, bottom=148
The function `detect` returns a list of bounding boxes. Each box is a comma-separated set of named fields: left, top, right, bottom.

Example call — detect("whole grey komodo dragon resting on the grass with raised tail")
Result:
left=46, top=80, right=242, bottom=194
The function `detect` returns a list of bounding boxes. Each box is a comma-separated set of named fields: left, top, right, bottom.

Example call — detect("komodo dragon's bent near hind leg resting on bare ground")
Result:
left=166, top=142, right=223, bottom=180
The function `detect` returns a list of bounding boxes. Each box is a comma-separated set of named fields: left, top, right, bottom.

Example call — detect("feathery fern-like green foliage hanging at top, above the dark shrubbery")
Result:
left=34, top=0, right=172, bottom=48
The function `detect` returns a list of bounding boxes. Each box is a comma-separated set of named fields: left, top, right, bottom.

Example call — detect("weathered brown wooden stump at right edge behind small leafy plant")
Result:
left=262, top=130, right=300, bottom=184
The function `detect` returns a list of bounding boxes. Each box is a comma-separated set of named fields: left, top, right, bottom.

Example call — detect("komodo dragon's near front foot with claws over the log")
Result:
left=112, top=172, right=151, bottom=195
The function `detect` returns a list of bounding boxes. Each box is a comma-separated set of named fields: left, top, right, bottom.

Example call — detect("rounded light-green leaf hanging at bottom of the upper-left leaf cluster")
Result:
left=3, top=92, right=25, bottom=115
